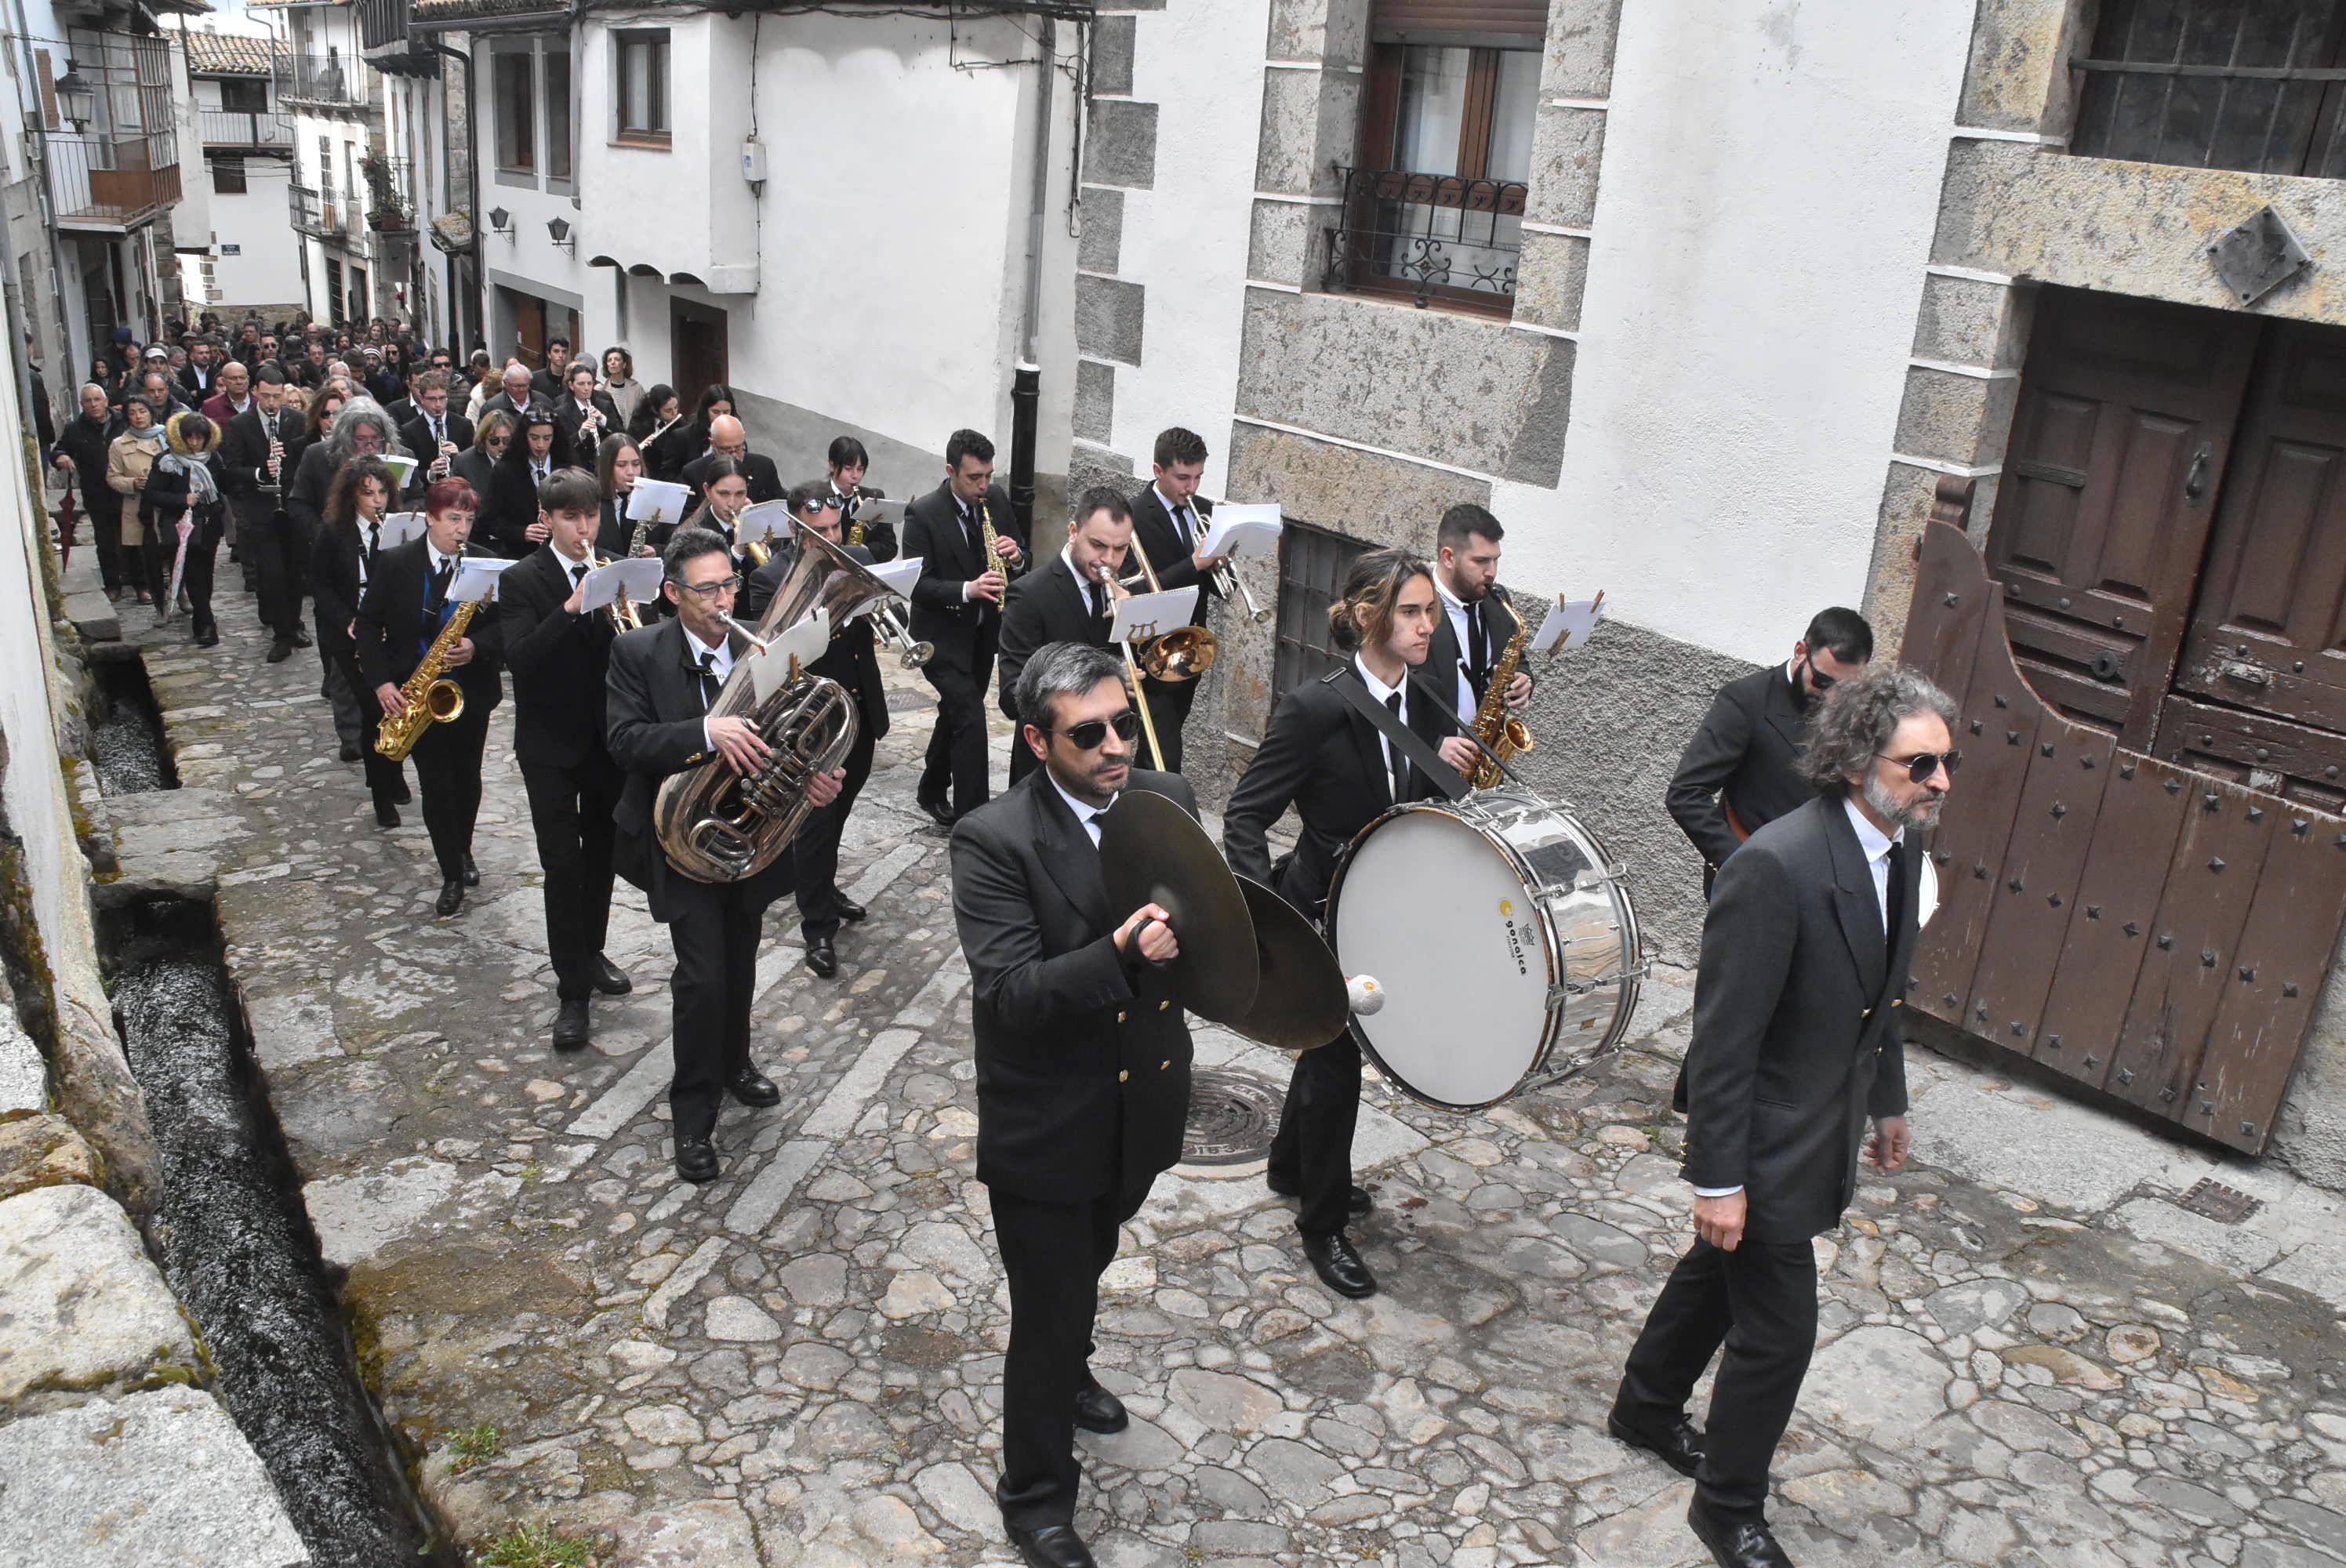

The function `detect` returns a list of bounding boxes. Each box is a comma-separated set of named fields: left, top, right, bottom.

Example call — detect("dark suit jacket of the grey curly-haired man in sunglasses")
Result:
left=1677, top=796, right=1923, bottom=1242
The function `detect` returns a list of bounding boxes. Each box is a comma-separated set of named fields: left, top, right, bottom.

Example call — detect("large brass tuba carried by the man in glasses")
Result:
left=652, top=517, right=894, bottom=883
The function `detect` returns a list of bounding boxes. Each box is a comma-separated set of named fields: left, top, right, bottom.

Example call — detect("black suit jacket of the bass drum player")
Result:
left=1222, top=664, right=1459, bottom=918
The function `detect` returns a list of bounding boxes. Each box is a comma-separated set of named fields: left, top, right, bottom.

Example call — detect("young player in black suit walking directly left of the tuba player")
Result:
left=497, top=467, right=631, bottom=1051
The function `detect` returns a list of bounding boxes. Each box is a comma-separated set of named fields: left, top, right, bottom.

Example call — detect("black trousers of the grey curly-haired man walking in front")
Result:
left=1623, top=1239, right=1816, bottom=1519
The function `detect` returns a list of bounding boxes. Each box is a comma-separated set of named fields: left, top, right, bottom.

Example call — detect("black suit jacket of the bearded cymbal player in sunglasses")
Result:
left=953, top=768, right=1197, bottom=1204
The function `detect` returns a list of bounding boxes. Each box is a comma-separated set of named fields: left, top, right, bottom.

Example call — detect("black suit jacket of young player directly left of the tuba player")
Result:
left=497, top=545, right=615, bottom=768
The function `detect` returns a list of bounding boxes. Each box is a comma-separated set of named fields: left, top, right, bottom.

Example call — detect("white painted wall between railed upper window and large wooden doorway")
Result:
left=1501, top=0, right=1973, bottom=659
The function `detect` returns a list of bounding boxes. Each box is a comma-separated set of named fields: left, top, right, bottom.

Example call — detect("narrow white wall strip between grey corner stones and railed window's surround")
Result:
left=1109, top=0, right=1269, bottom=500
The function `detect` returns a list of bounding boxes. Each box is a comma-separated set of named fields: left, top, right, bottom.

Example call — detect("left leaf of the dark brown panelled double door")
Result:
left=1987, top=289, right=2259, bottom=749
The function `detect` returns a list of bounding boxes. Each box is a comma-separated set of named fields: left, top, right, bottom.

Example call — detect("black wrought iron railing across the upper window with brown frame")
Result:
left=1320, top=167, right=1527, bottom=310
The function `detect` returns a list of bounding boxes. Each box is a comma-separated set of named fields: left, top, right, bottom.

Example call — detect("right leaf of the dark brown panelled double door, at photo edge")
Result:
left=2159, top=321, right=2346, bottom=810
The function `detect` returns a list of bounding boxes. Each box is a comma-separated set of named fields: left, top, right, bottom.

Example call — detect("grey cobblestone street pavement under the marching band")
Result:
left=91, top=601, right=2346, bottom=1568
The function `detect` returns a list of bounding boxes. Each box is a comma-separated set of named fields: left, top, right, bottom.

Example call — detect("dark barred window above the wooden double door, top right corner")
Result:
left=2069, top=0, right=2346, bottom=179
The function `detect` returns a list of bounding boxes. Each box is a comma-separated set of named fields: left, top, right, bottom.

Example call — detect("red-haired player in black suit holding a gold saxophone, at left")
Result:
left=357, top=479, right=504, bottom=916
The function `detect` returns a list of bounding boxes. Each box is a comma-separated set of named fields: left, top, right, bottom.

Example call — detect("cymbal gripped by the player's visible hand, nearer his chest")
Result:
left=1100, top=789, right=1260, bottom=1023
